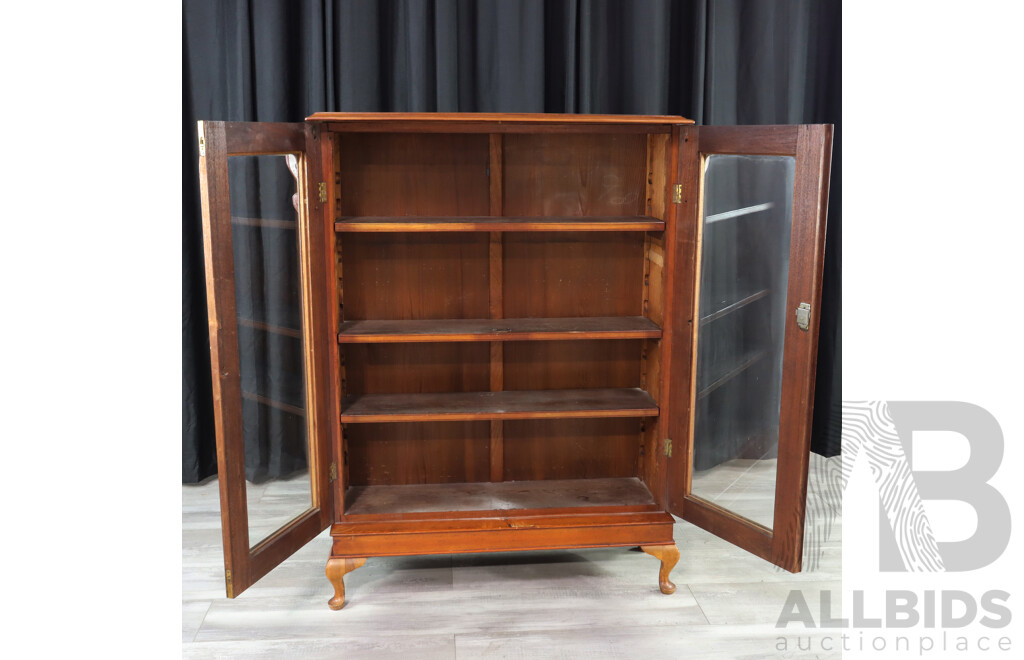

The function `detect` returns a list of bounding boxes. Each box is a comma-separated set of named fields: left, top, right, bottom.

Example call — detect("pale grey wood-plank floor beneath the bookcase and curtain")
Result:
left=181, top=454, right=842, bottom=660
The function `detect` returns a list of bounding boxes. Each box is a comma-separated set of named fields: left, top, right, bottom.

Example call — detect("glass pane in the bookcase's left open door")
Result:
left=228, top=156, right=312, bottom=546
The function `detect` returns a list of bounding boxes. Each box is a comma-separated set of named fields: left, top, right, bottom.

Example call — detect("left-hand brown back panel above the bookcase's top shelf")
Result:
left=337, top=133, right=490, bottom=216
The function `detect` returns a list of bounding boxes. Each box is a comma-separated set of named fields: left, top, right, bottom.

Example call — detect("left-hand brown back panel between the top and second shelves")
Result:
left=339, top=233, right=489, bottom=320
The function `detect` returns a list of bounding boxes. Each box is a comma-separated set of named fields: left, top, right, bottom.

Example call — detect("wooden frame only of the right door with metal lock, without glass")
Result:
left=667, top=125, right=831, bottom=572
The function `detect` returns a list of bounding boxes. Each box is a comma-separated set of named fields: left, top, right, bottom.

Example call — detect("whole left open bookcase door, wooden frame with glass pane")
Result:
left=199, top=122, right=332, bottom=598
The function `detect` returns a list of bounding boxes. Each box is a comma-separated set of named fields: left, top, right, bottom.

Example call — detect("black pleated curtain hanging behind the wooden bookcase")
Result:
left=181, top=0, right=842, bottom=482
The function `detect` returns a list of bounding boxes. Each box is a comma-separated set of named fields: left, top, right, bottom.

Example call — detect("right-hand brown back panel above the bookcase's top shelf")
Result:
left=502, top=134, right=647, bottom=216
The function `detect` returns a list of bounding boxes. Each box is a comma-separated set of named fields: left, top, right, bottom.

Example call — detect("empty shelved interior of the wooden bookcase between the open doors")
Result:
left=329, top=132, right=669, bottom=516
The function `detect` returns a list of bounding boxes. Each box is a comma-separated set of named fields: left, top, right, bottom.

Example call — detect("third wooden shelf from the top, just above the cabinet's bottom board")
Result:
left=341, top=388, right=658, bottom=424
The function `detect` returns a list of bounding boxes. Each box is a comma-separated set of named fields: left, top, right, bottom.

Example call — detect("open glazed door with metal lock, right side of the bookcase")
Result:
left=668, top=125, right=831, bottom=572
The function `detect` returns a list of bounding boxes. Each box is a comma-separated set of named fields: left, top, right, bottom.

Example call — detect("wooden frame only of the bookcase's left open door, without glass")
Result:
left=199, top=122, right=333, bottom=598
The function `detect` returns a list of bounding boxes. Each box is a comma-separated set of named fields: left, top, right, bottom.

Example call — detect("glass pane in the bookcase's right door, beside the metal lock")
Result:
left=690, top=151, right=796, bottom=528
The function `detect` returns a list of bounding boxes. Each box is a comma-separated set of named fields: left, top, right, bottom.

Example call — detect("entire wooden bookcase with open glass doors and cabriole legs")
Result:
left=199, top=114, right=831, bottom=609
